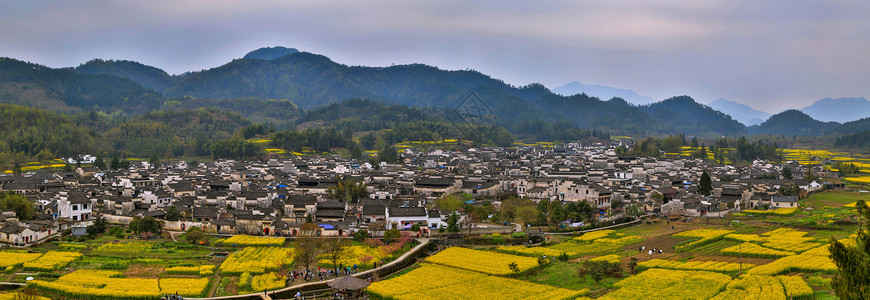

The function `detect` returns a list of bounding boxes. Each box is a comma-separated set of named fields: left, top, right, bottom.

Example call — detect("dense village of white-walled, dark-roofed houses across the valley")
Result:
left=0, top=144, right=826, bottom=245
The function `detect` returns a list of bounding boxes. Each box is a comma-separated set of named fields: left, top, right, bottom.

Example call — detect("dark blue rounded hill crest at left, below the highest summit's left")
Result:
left=75, top=59, right=181, bottom=92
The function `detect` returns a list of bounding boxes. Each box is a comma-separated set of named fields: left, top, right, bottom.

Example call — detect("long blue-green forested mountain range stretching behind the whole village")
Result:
left=0, top=47, right=870, bottom=137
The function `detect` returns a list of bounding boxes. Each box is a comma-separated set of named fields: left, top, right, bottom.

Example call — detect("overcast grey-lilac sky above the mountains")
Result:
left=0, top=0, right=870, bottom=113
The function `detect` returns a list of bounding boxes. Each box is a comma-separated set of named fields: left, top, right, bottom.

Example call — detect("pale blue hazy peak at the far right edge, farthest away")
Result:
left=801, top=97, right=870, bottom=123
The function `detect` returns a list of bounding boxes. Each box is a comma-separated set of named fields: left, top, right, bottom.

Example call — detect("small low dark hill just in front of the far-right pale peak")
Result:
left=749, top=109, right=840, bottom=136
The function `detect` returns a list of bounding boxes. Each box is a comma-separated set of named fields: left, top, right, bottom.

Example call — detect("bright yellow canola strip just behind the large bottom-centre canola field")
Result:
left=426, top=247, right=538, bottom=275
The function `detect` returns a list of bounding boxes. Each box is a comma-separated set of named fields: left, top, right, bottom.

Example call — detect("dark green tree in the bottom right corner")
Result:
left=829, top=200, right=870, bottom=300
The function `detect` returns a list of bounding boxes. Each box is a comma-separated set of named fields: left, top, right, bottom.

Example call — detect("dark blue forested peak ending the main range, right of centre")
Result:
left=640, top=96, right=746, bottom=136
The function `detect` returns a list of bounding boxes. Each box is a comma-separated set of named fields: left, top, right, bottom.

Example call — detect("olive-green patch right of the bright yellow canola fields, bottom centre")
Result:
left=519, top=261, right=621, bottom=294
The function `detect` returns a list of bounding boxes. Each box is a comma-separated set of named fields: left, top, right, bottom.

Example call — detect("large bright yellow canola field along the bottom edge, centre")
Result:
left=368, top=263, right=589, bottom=300
